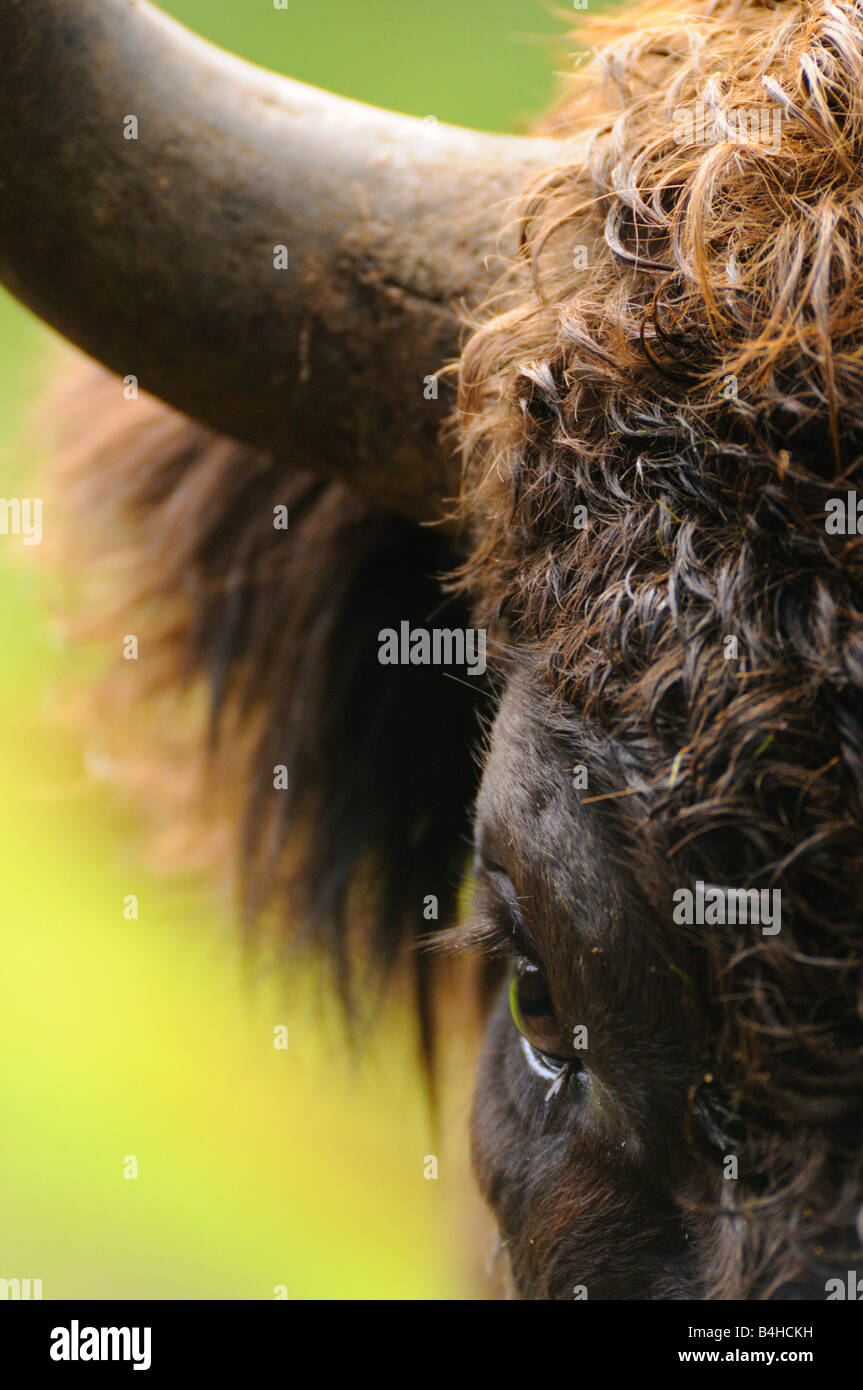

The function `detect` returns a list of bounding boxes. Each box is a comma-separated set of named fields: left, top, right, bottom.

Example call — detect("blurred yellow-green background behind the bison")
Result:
left=0, top=0, right=578, bottom=1298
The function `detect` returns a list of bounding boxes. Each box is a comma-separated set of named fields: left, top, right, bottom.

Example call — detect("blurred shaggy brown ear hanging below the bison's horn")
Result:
left=54, top=368, right=482, bottom=1045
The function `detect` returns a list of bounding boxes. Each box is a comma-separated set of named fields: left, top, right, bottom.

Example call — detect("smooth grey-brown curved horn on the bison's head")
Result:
left=0, top=0, right=556, bottom=517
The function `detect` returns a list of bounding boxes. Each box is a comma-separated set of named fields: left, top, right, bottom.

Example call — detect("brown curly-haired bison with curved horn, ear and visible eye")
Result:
left=0, top=0, right=863, bottom=1300
